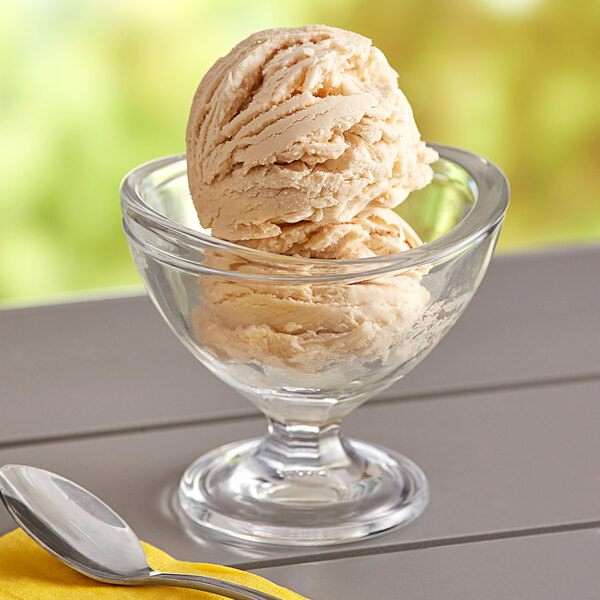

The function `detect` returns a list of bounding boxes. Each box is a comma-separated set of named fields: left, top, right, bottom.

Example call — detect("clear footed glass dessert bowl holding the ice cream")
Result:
left=121, top=144, right=509, bottom=545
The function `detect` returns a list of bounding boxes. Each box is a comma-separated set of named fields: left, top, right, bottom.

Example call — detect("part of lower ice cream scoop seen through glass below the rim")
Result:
left=192, top=269, right=429, bottom=372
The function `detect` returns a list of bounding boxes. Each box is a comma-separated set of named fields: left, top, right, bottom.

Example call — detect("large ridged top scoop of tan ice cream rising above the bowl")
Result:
left=186, top=25, right=437, bottom=241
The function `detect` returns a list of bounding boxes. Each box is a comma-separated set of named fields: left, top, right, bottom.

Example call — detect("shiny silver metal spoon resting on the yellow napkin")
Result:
left=0, top=465, right=277, bottom=600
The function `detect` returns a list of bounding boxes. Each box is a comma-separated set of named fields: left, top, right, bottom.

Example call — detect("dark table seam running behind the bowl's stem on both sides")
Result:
left=0, top=373, right=600, bottom=450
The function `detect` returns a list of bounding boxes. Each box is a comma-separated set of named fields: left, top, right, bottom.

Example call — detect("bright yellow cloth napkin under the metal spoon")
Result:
left=0, top=529, right=305, bottom=600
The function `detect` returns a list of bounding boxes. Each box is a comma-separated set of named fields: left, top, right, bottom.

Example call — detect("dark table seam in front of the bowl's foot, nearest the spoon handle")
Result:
left=237, top=520, right=600, bottom=571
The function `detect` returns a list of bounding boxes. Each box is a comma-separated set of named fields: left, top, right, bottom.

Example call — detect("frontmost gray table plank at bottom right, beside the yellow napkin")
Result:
left=257, top=530, right=600, bottom=600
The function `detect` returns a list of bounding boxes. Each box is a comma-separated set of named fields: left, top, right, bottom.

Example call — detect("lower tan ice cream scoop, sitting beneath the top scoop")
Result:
left=193, top=209, right=429, bottom=372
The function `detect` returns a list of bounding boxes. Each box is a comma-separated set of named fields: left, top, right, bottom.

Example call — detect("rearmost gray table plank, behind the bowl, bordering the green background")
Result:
left=0, top=247, right=600, bottom=442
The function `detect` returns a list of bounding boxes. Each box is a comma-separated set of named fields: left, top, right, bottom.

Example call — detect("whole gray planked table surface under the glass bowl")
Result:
left=0, top=247, right=600, bottom=600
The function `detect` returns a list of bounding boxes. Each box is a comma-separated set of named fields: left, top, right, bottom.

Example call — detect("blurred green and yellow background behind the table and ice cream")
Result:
left=0, top=0, right=600, bottom=302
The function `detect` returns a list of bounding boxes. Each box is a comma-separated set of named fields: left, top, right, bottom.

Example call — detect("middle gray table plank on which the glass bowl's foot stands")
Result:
left=0, top=382, right=600, bottom=565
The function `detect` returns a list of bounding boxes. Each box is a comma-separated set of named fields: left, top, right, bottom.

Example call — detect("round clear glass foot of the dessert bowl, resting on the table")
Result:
left=179, top=439, right=428, bottom=546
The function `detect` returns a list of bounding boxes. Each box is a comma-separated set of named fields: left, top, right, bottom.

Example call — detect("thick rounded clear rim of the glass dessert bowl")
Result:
left=119, top=143, right=510, bottom=281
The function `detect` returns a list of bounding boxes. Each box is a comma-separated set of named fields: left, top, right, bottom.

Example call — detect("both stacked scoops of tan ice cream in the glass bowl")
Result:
left=186, top=25, right=437, bottom=371
